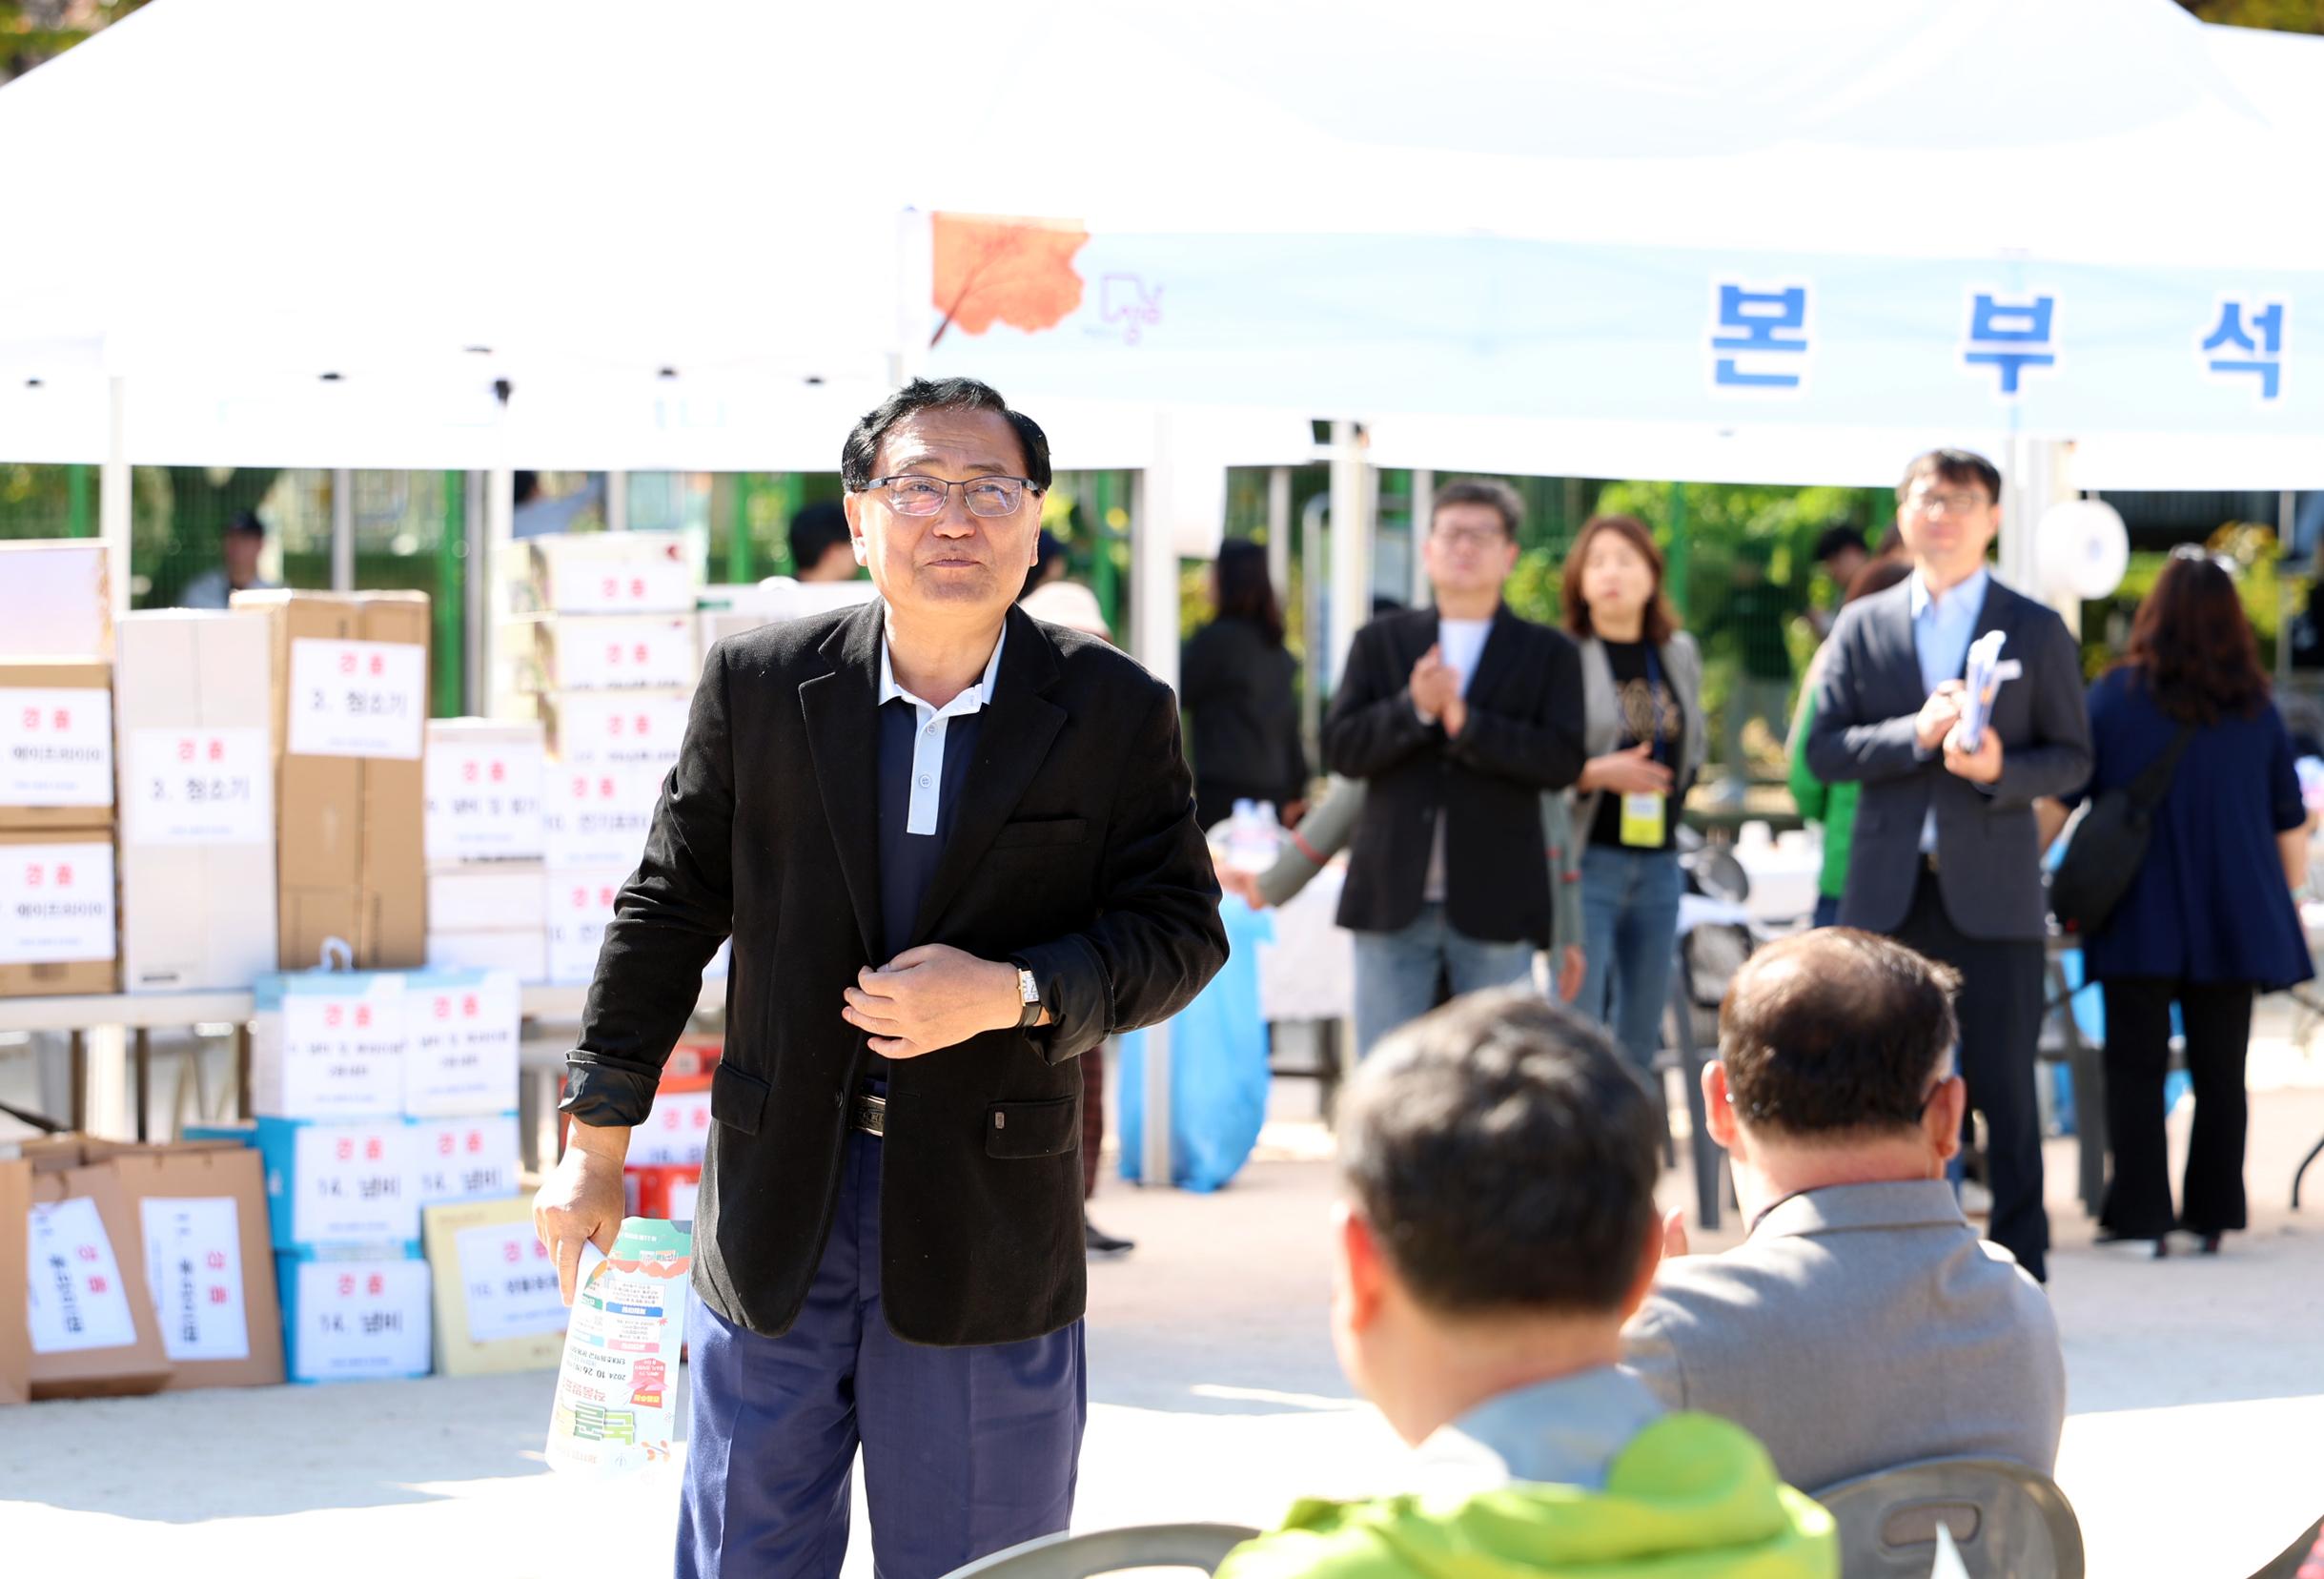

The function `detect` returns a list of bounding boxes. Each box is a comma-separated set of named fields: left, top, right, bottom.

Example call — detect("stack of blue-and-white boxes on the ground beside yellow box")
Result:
left=251, top=970, right=520, bottom=1382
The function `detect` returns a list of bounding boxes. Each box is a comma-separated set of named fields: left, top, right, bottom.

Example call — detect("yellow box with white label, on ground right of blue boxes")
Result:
left=425, top=1198, right=572, bottom=1377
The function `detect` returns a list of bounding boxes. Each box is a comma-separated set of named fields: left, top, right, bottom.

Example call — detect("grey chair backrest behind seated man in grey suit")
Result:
left=1813, top=1458, right=2082, bottom=1579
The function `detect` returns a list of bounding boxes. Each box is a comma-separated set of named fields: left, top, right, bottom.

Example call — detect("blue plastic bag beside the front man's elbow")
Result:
left=1113, top=895, right=1275, bottom=1191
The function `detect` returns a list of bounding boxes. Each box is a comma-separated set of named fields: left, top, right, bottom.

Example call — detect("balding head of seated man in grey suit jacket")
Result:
left=1703, top=926, right=1968, bottom=1217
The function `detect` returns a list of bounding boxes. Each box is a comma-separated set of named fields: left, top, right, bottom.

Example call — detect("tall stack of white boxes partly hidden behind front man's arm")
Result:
left=530, top=533, right=700, bottom=981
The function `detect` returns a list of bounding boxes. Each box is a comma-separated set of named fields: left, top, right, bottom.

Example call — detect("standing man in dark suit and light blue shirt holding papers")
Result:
left=1808, top=449, right=2090, bottom=1279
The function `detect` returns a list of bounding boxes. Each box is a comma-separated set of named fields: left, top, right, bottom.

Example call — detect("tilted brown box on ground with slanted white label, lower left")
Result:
left=26, top=1162, right=172, bottom=1398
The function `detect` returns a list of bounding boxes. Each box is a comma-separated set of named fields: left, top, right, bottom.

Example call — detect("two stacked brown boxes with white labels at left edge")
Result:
left=0, top=650, right=121, bottom=997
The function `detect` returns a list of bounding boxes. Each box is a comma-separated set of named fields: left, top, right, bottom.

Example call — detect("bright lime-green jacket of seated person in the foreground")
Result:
left=1218, top=1414, right=1841, bottom=1579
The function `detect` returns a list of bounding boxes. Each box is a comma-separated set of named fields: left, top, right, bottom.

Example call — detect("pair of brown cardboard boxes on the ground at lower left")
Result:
left=0, top=1135, right=283, bottom=1403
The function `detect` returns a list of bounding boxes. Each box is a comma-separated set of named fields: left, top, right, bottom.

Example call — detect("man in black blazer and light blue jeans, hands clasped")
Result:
left=1322, top=482, right=1582, bottom=1054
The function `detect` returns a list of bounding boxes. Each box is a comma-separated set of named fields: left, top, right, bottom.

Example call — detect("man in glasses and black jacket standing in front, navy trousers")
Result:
left=535, top=379, right=1227, bottom=1579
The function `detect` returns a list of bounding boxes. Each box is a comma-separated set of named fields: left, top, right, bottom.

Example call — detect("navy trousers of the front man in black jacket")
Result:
left=676, top=1133, right=1088, bottom=1579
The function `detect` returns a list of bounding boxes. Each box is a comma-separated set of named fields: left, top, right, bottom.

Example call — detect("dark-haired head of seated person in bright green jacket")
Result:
left=1338, top=991, right=1661, bottom=1316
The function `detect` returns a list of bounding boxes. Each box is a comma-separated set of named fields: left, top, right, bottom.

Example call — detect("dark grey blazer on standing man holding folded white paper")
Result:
left=1808, top=572, right=2090, bottom=942
